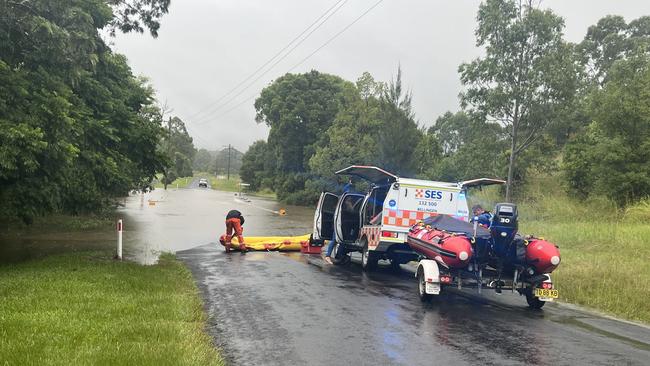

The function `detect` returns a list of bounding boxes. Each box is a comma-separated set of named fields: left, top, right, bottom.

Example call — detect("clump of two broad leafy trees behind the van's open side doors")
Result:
left=241, top=70, right=422, bottom=203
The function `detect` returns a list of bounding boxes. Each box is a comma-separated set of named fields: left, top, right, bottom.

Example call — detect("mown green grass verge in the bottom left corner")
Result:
left=0, top=252, right=223, bottom=365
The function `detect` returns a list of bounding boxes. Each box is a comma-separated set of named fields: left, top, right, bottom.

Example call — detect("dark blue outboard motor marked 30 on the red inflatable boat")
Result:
left=490, top=203, right=518, bottom=260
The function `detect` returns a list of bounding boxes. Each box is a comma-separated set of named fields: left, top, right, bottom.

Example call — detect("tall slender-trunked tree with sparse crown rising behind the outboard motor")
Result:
left=459, top=0, right=577, bottom=201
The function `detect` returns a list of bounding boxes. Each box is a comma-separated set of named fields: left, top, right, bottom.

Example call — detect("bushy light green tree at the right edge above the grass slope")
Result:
left=564, top=52, right=650, bottom=205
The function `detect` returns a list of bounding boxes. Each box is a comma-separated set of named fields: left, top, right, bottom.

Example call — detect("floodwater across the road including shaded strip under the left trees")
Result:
left=0, top=178, right=313, bottom=264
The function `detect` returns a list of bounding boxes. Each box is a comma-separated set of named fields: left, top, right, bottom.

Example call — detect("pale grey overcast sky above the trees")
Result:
left=112, top=0, right=650, bottom=151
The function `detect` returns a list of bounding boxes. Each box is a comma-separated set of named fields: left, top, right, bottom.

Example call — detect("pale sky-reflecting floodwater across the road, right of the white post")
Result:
left=120, top=179, right=313, bottom=264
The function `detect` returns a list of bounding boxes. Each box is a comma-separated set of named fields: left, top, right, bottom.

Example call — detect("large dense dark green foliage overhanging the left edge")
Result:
left=0, top=0, right=169, bottom=221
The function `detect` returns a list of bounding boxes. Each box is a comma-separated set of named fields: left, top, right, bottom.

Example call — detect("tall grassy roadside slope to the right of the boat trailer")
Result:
left=472, top=176, right=650, bottom=323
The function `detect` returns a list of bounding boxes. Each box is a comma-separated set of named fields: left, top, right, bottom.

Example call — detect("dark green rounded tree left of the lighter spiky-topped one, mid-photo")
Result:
left=255, top=71, right=354, bottom=203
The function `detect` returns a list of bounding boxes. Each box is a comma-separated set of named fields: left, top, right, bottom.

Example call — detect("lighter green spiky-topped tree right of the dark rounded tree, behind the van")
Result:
left=309, top=69, right=422, bottom=184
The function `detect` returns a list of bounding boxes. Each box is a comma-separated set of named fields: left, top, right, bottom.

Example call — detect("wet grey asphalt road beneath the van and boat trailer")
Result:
left=168, top=183, right=650, bottom=365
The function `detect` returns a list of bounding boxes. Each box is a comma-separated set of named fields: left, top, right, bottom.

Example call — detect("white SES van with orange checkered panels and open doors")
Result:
left=312, top=165, right=505, bottom=270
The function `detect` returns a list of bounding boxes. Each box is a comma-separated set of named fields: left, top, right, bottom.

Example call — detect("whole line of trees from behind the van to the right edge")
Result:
left=242, top=0, right=650, bottom=204
